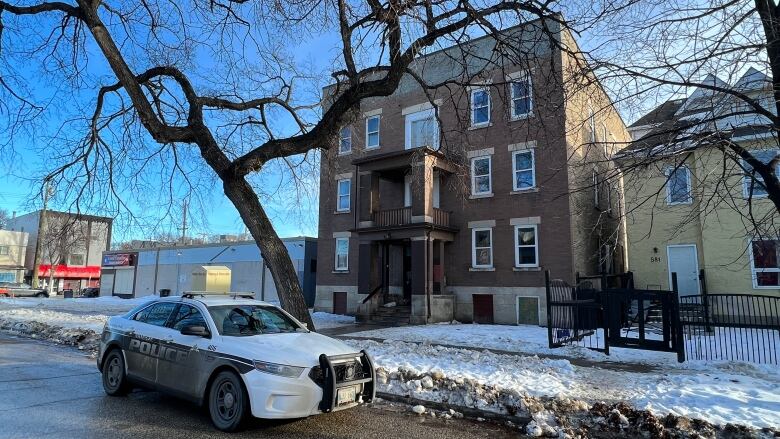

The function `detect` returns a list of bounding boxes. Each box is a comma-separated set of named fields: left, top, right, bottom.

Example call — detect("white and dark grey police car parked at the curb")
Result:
left=97, top=293, right=375, bottom=431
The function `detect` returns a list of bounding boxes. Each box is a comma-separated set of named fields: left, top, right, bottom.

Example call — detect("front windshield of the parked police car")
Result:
left=209, top=305, right=300, bottom=337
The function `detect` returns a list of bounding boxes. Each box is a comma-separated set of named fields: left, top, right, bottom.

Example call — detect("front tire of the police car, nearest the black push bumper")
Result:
left=208, top=371, right=250, bottom=432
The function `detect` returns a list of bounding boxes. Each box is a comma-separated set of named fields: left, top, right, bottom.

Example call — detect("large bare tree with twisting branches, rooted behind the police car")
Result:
left=0, top=0, right=580, bottom=327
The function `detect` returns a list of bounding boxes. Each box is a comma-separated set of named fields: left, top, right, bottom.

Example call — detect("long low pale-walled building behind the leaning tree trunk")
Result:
left=100, top=237, right=317, bottom=306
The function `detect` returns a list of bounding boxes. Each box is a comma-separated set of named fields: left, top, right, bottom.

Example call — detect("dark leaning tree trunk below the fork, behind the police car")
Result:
left=223, top=177, right=315, bottom=330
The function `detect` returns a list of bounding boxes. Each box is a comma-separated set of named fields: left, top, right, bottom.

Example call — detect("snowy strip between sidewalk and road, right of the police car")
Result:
left=349, top=340, right=780, bottom=428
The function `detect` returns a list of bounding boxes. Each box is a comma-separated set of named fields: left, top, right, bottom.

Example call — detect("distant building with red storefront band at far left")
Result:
left=7, top=210, right=113, bottom=291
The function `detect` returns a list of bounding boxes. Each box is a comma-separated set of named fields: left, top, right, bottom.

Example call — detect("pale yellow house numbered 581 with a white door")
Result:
left=618, top=69, right=780, bottom=300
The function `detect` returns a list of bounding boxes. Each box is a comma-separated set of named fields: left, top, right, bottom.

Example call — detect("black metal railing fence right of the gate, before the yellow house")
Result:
left=680, top=294, right=780, bottom=364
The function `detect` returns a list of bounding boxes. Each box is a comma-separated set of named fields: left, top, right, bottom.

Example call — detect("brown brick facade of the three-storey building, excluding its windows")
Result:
left=316, top=22, right=622, bottom=324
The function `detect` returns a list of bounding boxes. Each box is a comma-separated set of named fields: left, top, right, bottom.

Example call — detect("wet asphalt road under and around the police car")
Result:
left=0, top=334, right=518, bottom=439
